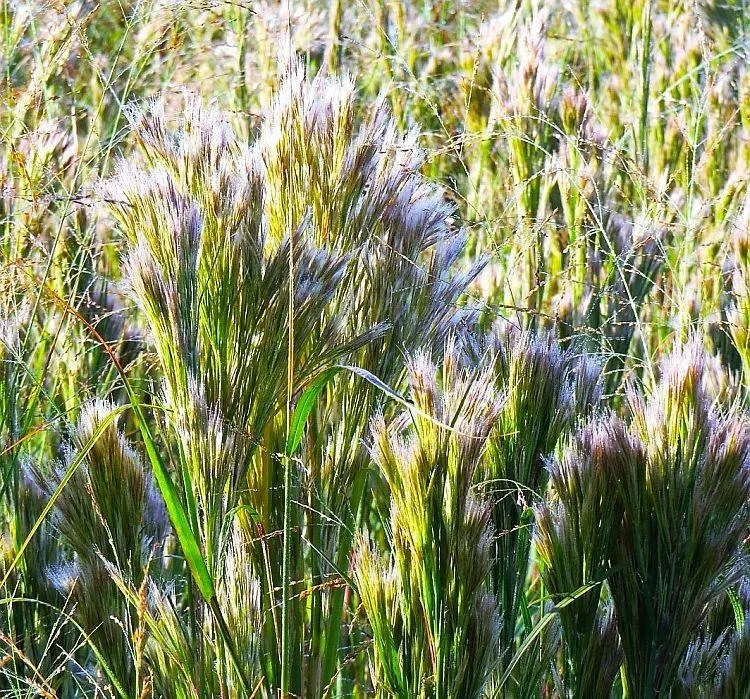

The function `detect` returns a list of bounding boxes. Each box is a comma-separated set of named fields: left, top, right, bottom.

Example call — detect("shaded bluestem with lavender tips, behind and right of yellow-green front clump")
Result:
left=471, top=324, right=601, bottom=680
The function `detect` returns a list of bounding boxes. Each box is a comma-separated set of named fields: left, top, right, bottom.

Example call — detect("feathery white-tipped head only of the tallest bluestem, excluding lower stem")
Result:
left=253, top=57, right=484, bottom=360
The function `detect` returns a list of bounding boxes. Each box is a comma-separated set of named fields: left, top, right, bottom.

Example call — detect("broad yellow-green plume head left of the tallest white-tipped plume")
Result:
left=102, top=91, right=369, bottom=442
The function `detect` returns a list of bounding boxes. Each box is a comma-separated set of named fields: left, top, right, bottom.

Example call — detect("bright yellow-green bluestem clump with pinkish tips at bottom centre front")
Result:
left=353, top=343, right=500, bottom=699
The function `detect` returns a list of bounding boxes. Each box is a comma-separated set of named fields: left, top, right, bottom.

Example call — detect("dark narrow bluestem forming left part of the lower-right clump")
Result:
left=534, top=416, right=630, bottom=697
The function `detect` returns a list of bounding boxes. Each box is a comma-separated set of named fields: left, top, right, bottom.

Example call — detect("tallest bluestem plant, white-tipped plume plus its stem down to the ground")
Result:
left=258, top=65, right=484, bottom=694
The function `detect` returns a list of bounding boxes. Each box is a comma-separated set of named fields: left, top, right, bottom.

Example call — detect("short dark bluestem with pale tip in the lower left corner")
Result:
left=29, top=403, right=167, bottom=692
